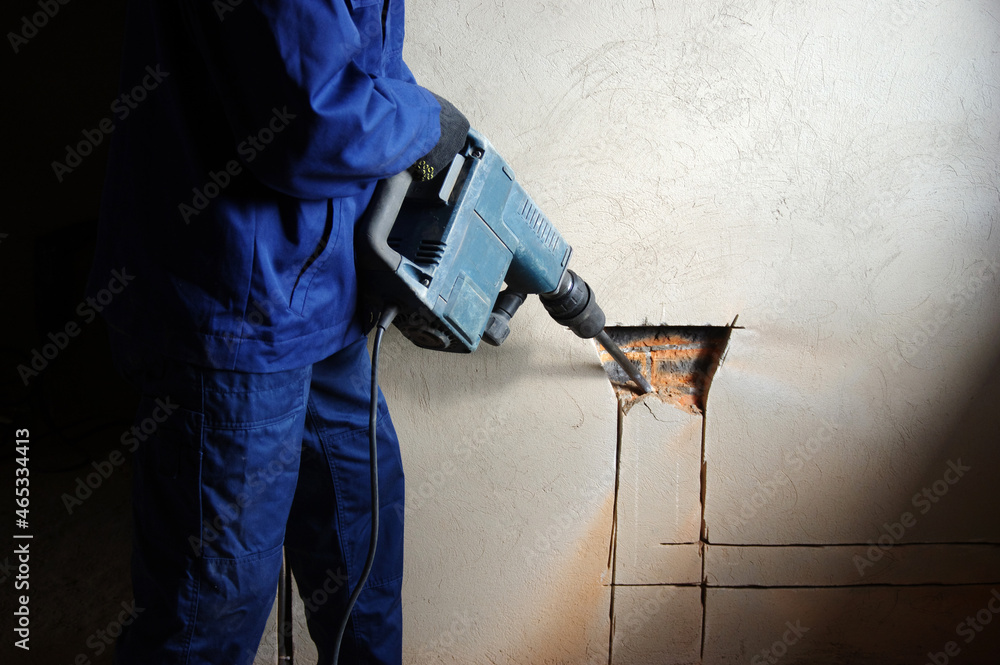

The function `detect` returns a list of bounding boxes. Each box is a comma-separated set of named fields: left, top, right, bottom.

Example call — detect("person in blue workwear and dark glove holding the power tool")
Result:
left=88, top=0, right=469, bottom=665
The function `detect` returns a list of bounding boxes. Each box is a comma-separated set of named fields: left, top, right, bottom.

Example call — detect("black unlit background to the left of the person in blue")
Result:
left=0, top=0, right=143, bottom=665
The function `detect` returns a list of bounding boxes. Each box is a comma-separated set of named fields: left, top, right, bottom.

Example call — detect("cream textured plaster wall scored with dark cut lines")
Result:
left=262, top=0, right=1000, bottom=663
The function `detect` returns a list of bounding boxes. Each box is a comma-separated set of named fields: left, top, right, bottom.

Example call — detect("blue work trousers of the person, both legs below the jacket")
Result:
left=116, top=339, right=404, bottom=665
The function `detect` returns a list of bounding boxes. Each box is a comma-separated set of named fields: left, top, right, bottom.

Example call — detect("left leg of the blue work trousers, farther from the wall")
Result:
left=118, top=366, right=309, bottom=665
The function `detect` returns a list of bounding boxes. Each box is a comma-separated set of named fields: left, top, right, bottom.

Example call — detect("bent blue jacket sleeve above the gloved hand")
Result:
left=182, top=0, right=440, bottom=199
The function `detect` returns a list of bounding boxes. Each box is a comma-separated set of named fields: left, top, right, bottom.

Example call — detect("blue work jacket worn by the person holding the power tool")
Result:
left=88, top=0, right=440, bottom=372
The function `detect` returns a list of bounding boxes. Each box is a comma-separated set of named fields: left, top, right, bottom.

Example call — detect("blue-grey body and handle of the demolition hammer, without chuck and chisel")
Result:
left=359, top=130, right=572, bottom=353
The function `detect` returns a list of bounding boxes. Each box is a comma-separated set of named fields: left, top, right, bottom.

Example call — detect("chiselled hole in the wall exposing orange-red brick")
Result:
left=597, top=319, right=736, bottom=414
